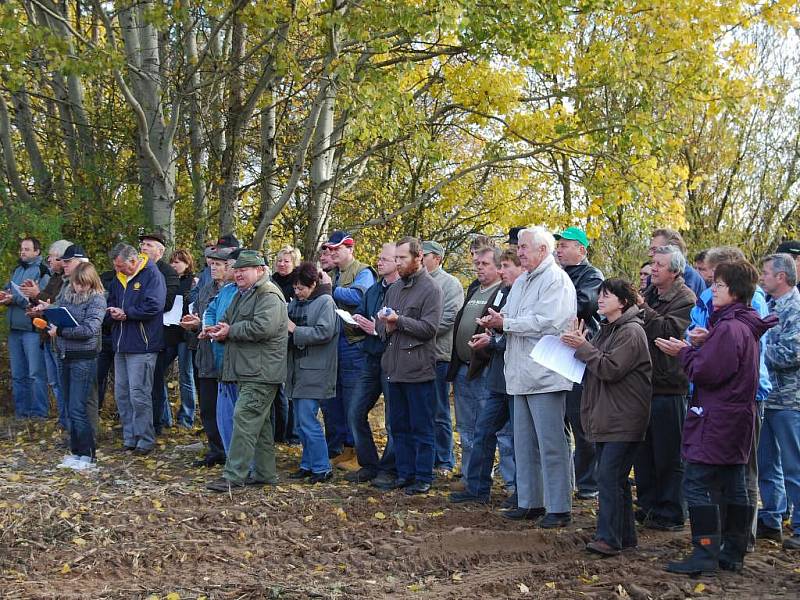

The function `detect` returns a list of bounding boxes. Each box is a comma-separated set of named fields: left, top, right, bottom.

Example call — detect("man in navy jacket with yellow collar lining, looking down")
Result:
left=106, top=244, right=167, bottom=454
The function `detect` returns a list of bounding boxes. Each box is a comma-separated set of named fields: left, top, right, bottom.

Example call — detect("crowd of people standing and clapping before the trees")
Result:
left=0, top=226, right=800, bottom=574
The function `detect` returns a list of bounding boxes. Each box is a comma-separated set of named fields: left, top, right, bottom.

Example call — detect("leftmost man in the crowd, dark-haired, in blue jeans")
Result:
left=0, top=237, right=50, bottom=419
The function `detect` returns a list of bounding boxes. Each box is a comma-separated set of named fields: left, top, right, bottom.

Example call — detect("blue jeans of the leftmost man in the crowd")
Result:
left=8, top=329, right=50, bottom=419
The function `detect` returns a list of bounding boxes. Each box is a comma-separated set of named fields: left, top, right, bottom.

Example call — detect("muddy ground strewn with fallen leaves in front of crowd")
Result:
left=0, top=406, right=800, bottom=600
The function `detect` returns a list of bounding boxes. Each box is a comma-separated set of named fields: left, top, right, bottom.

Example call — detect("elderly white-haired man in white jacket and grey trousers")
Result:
left=480, top=227, right=578, bottom=529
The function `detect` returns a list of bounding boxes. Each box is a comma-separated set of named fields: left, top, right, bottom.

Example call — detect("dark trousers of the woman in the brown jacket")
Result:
left=594, top=442, right=640, bottom=550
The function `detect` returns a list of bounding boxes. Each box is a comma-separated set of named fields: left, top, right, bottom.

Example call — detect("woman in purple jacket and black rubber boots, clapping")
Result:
left=656, top=261, right=776, bottom=575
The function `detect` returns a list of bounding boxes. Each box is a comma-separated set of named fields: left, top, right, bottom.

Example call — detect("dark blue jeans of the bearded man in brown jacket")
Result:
left=389, top=381, right=436, bottom=483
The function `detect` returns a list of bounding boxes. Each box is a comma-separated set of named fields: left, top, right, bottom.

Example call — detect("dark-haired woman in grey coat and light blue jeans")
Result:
left=286, top=262, right=339, bottom=483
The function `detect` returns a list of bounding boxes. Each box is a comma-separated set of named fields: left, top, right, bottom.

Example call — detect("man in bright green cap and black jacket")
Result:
left=555, top=227, right=603, bottom=500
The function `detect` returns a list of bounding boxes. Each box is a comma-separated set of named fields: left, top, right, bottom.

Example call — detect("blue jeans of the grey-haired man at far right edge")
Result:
left=758, top=408, right=800, bottom=534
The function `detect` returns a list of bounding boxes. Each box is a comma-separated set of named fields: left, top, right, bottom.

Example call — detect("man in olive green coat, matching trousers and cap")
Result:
left=206, top=250, right=289, bottom=492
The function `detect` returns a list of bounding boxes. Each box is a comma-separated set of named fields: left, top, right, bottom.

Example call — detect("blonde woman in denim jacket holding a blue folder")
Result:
left=47, top=263, right=106, bottom=471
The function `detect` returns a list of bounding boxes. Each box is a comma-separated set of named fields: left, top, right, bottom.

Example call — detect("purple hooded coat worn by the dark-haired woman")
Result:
left=679, top=303, right=777, bottom=465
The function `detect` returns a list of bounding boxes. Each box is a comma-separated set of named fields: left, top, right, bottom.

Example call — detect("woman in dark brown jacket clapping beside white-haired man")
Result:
left=561, top=278, right=653, bottom=556
